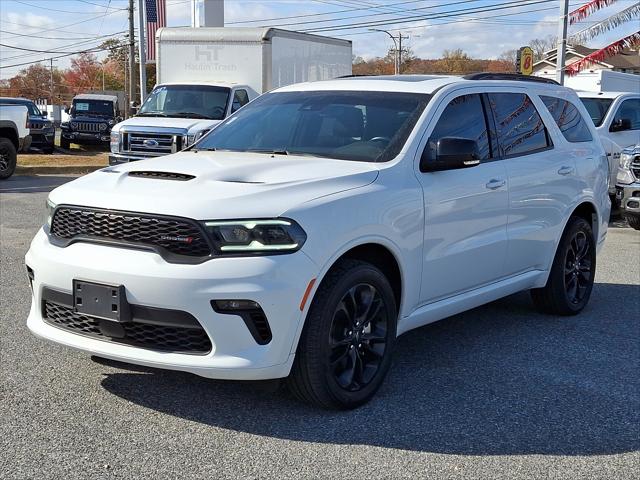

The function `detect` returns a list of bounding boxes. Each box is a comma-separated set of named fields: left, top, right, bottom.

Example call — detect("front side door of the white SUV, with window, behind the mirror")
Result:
left=418, top=93, right=508, bottom=304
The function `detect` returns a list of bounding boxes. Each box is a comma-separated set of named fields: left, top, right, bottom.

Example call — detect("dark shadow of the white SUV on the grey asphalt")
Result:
left=102, top=284, right=640, bottom=455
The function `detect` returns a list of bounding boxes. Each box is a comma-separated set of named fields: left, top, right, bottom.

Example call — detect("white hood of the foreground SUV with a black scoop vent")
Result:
left=50, top=151, right=378, bottom=220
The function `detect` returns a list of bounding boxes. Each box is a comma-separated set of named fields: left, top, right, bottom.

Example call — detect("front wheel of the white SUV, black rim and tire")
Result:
left=287, top=260, right=398, bottom=410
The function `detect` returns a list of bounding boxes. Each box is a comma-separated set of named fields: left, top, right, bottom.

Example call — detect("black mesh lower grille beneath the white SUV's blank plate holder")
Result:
left=42, top=300, right=211, bottom=354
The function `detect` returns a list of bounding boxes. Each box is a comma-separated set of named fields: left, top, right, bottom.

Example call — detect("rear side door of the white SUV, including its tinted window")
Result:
left=487, top=91, right=579, bottom=276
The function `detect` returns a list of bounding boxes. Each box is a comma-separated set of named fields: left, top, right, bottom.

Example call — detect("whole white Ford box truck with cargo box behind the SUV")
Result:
left=109, top=28, right=351, bottom=165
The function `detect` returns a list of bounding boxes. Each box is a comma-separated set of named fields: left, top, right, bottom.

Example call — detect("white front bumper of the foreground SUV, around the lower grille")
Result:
left=25, top=229, right=317, bottom=380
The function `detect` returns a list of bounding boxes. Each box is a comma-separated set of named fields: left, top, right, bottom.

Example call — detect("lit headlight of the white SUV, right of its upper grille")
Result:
left=204, top=218, right=307, bottom=255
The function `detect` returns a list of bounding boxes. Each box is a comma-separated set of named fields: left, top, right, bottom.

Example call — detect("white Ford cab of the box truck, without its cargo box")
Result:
left=109, top=82, right=258, bottom=165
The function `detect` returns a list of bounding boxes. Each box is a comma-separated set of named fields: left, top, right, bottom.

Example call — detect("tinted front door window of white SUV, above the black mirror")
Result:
left=428, top=94, right=490, bottom=160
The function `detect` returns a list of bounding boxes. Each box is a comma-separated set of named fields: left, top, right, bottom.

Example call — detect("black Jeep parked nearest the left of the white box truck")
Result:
left=60, top=93, right=122, bottom=149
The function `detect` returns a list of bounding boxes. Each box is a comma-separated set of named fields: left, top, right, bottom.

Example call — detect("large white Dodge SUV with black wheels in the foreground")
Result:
left=26, top=75, right=610, bottom=408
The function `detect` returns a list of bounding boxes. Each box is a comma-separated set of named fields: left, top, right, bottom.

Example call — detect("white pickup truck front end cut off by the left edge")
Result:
left=0, top=104, right=31, bottom=180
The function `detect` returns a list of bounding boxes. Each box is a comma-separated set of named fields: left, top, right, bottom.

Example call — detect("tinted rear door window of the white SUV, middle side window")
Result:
left=487, top=93, right=551, bottom=156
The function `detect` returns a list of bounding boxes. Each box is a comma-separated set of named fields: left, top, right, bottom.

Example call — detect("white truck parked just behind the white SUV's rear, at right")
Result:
left=577, top=91, right=640, bottom=196
